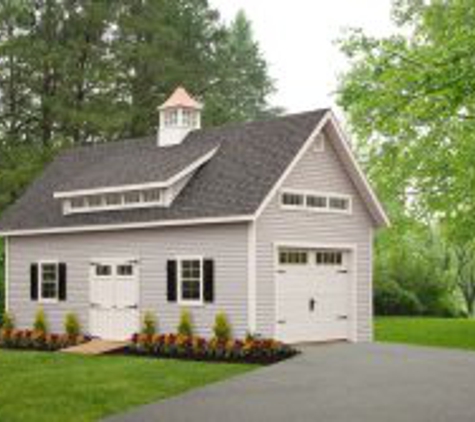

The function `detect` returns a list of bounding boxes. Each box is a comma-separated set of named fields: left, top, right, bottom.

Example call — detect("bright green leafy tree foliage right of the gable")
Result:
left=338, top=0, right=475, bottom=311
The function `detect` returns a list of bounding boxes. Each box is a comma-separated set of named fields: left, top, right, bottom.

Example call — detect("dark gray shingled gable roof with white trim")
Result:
left=0, top=109, right=387, bottom=235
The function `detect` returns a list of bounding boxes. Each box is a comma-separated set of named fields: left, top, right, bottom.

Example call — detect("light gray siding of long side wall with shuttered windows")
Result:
left=9, top=223, right=247, bottom=337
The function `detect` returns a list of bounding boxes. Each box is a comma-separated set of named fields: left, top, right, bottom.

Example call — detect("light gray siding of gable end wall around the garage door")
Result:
left=256, top=132, right=373, bottom=341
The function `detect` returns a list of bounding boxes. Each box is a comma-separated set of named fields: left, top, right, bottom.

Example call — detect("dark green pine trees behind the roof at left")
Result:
left=0, top=0, right=273, bottom=212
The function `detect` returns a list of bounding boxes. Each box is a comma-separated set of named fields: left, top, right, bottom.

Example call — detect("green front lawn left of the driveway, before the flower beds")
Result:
left=0, top=350, right=255, bottom=422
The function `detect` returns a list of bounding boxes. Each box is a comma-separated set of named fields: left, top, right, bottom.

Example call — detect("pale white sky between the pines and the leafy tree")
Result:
left=210, top=0, right=393, bottom=112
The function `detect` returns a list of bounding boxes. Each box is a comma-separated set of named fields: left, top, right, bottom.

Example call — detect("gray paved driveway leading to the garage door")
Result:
left=108, top=344, right=475, bottom=422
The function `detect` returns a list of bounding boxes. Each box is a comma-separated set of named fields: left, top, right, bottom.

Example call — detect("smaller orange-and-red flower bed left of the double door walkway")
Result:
left=0, top=330, right=90, bottom=352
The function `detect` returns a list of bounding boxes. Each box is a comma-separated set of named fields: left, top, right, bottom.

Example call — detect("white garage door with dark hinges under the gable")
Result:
left=276, top=248, right=351, bottom=343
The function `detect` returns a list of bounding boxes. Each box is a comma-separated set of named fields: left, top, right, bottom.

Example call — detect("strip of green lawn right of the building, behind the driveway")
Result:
left=375, top=317, right=475, bottom=350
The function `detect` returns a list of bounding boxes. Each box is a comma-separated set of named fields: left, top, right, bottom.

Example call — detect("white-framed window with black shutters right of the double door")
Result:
left=177, top=257, right=203, bottom=305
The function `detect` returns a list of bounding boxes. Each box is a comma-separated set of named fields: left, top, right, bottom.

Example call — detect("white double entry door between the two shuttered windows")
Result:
left=89, top=259, right=140, bottom=340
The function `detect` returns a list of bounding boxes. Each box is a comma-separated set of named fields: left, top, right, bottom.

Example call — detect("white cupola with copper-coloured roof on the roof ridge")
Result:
left=157, top=87, right=203, bottom=147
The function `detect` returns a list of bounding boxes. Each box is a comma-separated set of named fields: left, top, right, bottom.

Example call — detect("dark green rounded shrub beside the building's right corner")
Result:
left=374, top=280, right=423, bottom=315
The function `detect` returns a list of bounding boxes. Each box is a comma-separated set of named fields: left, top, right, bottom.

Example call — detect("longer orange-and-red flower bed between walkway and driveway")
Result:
left=126, top=334, right=299, bottom=365
